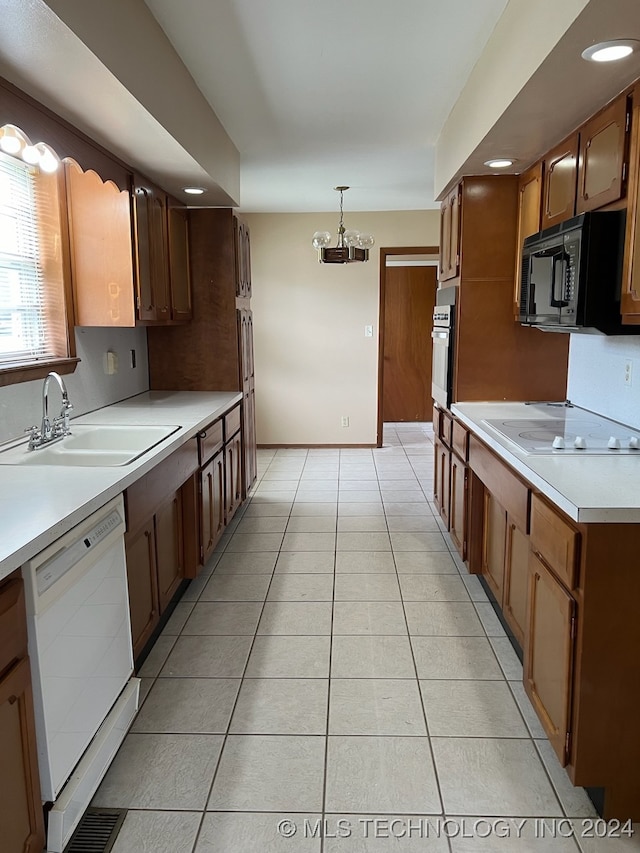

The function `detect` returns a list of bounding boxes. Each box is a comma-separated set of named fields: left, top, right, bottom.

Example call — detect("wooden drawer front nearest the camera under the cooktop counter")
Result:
left=531, top=495, right=580, bottom=589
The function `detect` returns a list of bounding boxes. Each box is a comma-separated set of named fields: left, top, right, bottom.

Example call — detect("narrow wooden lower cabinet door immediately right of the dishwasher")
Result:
left=125, top=518, right=160, bottom=659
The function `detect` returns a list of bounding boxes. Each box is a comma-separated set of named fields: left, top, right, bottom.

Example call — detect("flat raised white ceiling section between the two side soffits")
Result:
left=146, top=0, right=506, bottom=212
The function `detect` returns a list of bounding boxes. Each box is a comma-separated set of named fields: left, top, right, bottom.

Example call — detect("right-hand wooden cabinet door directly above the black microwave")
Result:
left=576, top=95, right=630, bottom=213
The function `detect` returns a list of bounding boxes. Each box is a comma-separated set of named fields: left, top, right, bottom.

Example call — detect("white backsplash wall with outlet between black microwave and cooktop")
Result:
left=567, top=335, right=640, bottom=429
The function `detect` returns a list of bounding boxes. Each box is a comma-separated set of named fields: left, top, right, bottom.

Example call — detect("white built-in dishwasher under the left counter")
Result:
left=22, top=495, right=140, bottom=853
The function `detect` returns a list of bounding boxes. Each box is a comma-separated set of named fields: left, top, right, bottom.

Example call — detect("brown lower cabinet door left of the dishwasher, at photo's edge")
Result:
left=0, top=658, right=44, bottom=853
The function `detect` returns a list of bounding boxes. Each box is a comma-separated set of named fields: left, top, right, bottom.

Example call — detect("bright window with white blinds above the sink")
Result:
left=0, top=143, right=75, bottom=384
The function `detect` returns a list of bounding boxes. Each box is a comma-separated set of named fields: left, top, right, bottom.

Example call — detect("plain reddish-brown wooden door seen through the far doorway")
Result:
left=382, top=266, right=437, bottom=422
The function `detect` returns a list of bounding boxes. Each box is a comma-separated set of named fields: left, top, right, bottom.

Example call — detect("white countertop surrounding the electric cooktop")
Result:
left=451, top=403, right=640, bottom=524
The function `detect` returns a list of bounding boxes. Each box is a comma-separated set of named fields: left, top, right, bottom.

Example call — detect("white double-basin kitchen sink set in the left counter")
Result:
left=0, top=423, right=180, bottom=467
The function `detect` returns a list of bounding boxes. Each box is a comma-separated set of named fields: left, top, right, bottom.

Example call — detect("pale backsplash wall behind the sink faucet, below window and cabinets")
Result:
left=0, top=328, right=149, bottom=441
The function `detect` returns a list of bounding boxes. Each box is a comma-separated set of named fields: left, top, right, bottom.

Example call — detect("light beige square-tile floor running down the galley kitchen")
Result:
left=94, top=424, right=640, bottom=853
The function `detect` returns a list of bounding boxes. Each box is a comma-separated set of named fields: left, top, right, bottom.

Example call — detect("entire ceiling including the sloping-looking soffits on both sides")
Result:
left=0, top=0, right=640, bottom=213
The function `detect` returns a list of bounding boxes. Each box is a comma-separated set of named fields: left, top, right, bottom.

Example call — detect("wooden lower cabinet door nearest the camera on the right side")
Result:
left=524, top=552, right=575, bottom=767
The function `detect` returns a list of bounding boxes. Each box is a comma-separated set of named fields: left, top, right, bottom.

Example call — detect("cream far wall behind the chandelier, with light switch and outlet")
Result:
left=246, top=210, right=440, bottom=445
